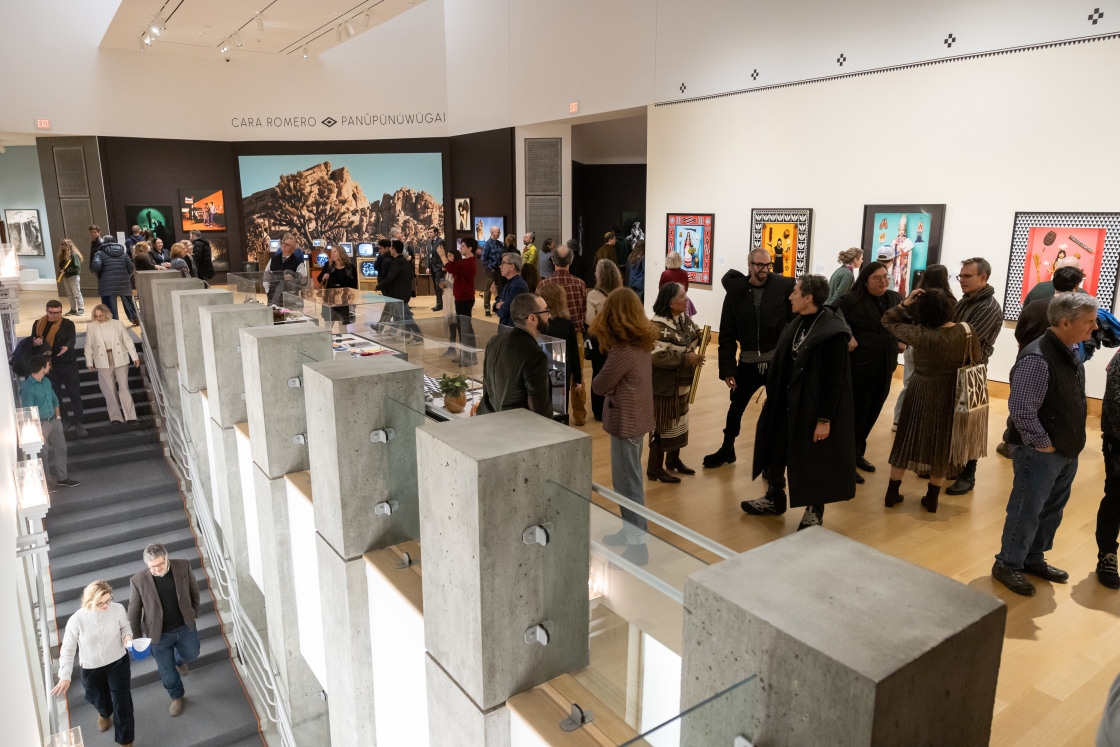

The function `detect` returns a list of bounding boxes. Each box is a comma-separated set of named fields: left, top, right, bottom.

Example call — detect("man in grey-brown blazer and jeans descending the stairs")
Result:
left=129, top=544, right=198, bottom=716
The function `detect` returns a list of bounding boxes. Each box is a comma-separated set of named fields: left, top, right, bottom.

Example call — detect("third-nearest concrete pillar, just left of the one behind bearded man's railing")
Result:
left=304, top=356, right=423, bottom=747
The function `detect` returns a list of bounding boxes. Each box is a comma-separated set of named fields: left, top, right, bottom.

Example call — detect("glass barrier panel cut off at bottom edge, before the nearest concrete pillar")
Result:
left=622, top=674, right=759, bottom=747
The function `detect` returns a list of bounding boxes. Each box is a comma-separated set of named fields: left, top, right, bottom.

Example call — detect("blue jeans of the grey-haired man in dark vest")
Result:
left=996, top=446, right=1077, bottom=570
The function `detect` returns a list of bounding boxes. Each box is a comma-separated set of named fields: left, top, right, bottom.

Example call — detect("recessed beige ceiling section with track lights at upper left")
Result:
left=101, top=0, right=424, bottom=57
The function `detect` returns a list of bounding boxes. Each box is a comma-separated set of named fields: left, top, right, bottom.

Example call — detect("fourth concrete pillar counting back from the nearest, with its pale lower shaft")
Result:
left=240, top=319, right=331, bottom=747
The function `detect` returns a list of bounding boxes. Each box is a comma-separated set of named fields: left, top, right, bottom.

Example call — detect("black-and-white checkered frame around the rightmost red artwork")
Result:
left=1004, top=213, right=1120, bottom=321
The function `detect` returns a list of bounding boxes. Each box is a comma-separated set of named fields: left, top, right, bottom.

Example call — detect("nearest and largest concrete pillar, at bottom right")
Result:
left=680, top=529, right=1007, bottom=747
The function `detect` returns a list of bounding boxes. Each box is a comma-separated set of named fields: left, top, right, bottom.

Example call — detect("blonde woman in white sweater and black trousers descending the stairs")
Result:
left=50, top=581, right=136, bottom=747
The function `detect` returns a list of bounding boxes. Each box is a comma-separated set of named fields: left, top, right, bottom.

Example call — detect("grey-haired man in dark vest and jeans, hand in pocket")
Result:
left=991, top=293, right=1098, bottom=597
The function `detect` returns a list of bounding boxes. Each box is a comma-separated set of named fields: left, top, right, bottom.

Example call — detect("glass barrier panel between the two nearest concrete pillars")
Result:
left=545, top=480, right=707, bottom=735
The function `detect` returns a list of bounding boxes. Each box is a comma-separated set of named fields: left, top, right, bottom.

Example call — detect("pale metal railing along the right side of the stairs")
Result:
left=140, top=323, right=296, bottom=747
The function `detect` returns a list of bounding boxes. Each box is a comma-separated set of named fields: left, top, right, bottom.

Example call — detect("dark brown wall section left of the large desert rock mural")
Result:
left=99, top=138, right=245, bottom=282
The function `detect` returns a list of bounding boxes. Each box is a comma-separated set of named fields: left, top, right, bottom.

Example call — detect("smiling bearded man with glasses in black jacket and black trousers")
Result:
left=703, top=249, right=794, bottom=467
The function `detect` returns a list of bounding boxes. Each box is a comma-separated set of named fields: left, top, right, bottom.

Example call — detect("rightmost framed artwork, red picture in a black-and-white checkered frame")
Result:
left=1004, top=213, right=1120, bottom=321
